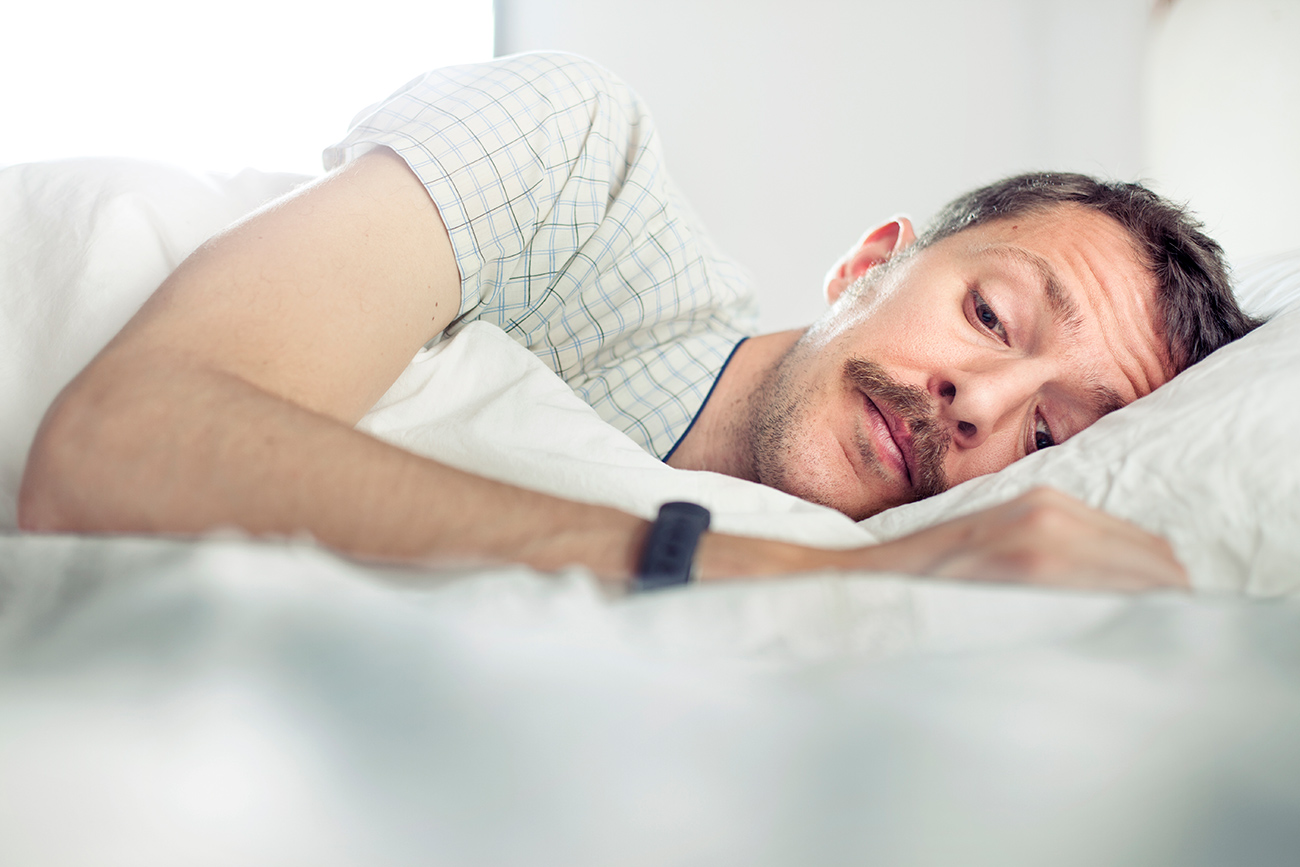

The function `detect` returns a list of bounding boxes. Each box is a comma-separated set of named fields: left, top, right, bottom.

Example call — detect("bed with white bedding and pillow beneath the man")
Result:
left=0, top=106, right=1300, bottom=864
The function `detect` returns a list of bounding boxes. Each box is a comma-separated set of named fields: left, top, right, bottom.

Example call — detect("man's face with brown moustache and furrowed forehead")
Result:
left=750, top=205, right=1171, bottom=520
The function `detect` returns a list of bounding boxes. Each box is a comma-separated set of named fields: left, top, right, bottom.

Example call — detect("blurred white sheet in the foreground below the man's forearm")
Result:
left=0, top=537, right=1300, bottom=867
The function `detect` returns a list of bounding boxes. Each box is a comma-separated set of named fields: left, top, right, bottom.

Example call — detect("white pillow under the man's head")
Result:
left=865, top=251, right=1300, bottom=595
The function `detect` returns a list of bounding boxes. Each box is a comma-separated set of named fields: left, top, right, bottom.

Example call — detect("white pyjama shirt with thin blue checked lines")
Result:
left=325, top=53, right=755, bottom=456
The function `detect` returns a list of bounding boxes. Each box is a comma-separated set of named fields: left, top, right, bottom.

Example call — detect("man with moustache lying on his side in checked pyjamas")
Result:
left=20, top=55, right=1252, bottom=588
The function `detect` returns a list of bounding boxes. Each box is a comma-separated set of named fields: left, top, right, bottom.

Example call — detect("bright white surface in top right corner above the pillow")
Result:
left=1144, top=0, right=1300, bottom=265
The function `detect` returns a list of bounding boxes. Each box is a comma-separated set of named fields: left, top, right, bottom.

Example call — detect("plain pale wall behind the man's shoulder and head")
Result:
left=497, top=0, right=1149, bottom=328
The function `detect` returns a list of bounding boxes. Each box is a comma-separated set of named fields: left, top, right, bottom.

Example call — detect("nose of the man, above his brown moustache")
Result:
left=930, top=365, right=1040, bottom=448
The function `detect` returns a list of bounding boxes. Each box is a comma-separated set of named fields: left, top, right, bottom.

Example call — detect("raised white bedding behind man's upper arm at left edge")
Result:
left=0, top=160, right=306, bottom=529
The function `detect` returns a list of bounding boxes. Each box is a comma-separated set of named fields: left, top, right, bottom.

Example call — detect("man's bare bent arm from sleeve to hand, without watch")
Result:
left=20, top=149, right=1180, bottom=586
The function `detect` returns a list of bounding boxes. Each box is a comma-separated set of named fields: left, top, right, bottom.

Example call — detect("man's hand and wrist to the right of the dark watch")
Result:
left=701, top=487, right=1190, bottom=590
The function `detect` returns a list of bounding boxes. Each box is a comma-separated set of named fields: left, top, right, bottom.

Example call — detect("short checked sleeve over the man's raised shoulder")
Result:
left=325, top=53, right=640, bottom=324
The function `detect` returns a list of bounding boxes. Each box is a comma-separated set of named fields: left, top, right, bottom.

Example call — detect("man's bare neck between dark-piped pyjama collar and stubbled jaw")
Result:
left=668, top=329, right=803, bottom=481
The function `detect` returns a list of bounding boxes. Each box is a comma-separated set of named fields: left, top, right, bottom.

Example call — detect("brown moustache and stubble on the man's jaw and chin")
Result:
left=749, top=296, right=952, bottom=520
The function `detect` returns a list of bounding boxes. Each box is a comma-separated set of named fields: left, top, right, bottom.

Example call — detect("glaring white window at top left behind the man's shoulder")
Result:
left=0, top=0, right=493, bottom=174
